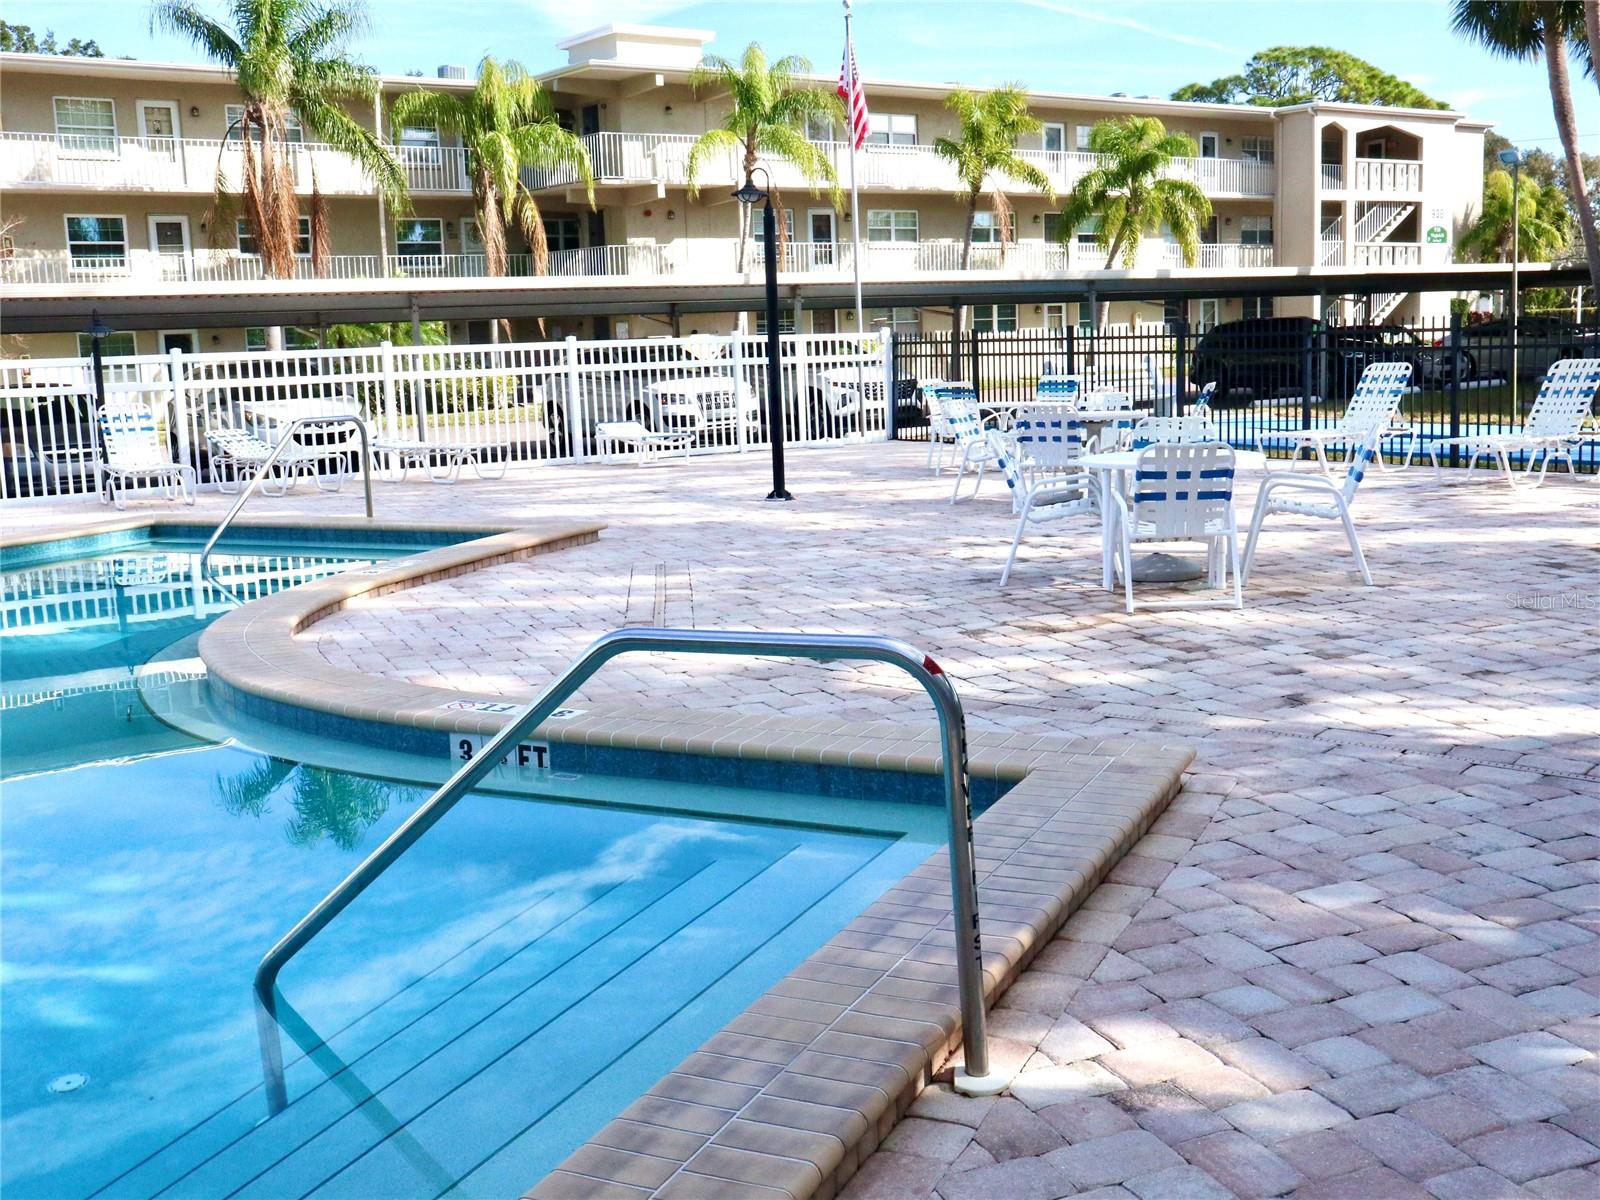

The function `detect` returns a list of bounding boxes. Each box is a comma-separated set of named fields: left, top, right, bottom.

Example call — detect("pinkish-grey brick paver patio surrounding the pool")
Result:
left=8, top=446, right=1600, bottom=1200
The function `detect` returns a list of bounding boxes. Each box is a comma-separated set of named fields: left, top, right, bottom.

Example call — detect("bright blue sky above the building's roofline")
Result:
left=0, top=0, right=1600, bottom=154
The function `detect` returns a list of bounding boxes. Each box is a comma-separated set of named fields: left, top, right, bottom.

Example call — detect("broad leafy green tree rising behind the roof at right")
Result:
left=1173, top=46, right=1448, bottom=109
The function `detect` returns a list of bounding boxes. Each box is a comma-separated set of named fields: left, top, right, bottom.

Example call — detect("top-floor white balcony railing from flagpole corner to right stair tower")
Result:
left=523, top=133, right=1275, bottom=195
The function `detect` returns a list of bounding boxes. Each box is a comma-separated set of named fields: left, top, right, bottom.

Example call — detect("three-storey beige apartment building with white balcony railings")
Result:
left=0, top=26, right=1486, bottom=355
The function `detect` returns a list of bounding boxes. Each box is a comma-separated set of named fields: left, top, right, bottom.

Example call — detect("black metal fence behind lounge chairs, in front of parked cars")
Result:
left=891, top=317, right=1600, bottom=472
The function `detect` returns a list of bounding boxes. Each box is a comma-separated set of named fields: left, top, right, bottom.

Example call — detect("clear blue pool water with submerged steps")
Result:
left=0, top=546, right=938, bottom=1200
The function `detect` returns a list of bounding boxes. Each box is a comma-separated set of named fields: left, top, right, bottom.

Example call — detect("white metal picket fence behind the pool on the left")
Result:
left=0, top=333, right=909, bottom=499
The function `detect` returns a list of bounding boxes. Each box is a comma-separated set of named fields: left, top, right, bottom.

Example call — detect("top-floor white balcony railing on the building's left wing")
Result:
left=0, top=133, right=470, bottom=195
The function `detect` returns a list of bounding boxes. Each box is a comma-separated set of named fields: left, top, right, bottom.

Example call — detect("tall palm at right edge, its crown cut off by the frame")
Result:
left=1451, top=0, right=1600, bottom=294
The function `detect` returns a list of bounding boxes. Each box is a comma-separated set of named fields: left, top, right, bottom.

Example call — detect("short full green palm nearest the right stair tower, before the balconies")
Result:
left=1061, top=117, right=1211, bottom=328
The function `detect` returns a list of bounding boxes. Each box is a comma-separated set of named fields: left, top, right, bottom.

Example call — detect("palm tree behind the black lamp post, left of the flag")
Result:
left=686, top=42, right=845, bottom=272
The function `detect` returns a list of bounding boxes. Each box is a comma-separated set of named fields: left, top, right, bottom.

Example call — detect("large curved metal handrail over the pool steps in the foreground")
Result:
left=254, top=629, right=998, bottom=1112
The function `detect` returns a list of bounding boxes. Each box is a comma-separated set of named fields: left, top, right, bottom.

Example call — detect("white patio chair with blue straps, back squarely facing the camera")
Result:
left=1110, top=442, right=1245, bottom=613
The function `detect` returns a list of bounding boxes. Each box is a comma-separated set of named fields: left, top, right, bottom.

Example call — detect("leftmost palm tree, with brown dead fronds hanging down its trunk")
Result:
left=150, top=0, right=406, bottom=310
